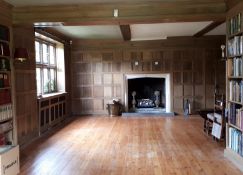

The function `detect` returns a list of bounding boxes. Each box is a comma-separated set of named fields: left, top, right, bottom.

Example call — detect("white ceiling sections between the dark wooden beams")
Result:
left=50, top=21, right=226, bottom=41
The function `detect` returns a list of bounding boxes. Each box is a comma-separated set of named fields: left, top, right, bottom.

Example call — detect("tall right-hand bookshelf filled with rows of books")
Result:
left=224, top=4, right=243, bottom=171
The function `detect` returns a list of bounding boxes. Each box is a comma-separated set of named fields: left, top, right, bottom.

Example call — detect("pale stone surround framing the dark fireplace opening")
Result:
left=124, top=74, right=171, bottom=113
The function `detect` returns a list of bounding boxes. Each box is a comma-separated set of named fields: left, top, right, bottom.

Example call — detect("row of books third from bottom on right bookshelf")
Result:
left=229, top=80, right=243, bottom=103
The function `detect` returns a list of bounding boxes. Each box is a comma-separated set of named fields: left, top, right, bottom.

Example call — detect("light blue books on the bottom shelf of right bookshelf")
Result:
left=229, top=127, right=243, bottom=156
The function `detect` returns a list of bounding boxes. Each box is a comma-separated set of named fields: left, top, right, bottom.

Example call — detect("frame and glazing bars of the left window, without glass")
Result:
left=35, top=37, right=58, bottom=95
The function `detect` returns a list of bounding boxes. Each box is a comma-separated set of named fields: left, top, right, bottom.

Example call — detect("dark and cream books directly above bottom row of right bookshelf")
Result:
left=228, top=103, right=243, bottom=130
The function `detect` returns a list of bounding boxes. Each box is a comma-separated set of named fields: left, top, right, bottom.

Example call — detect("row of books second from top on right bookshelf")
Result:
left=228, top=36, right=243, bottom=56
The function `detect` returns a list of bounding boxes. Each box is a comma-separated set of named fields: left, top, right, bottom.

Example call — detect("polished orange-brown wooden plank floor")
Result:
left=20, top=117, right=242, bottom=175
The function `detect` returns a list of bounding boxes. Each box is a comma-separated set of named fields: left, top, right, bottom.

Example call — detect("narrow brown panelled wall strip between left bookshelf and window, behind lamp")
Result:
left=13, top=26, right=38, bottom=145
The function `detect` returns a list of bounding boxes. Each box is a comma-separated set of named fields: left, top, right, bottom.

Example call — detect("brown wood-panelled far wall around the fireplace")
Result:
left=71, top=37, right=225, bottom=115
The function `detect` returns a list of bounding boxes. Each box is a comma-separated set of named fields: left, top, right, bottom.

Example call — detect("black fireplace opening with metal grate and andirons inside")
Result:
left=128, top=77, right=166, bottom=111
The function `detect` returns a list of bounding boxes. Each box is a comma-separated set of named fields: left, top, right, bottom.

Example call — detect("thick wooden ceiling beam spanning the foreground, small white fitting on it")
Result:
left=13, top=0, right=226, bottom=25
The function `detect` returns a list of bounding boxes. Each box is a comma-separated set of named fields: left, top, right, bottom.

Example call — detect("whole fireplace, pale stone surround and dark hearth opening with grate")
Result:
left=125, top=74, right=171, bottom=112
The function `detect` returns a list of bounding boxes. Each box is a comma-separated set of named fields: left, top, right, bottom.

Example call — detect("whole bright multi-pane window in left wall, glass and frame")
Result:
left=35, top=38, right=57, bottom=95
